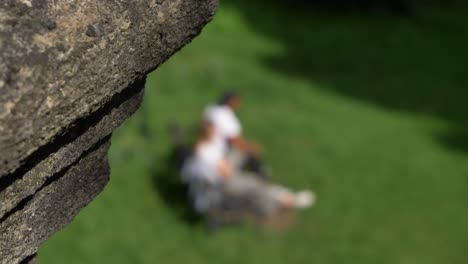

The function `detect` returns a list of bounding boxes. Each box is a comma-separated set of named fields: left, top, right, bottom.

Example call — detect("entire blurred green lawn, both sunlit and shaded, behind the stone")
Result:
left=38, top=0, right=468, bottom=264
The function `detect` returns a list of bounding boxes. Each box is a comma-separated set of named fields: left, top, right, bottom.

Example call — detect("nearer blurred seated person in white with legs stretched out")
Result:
left=182, top=121, right=315, bottom=216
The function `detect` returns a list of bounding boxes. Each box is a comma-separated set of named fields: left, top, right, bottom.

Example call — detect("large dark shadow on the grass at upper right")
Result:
left=224, top=0, right=468, bottom=153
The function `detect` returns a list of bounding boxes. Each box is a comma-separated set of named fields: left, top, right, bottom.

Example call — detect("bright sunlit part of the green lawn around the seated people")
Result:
left=39, top=2, right=468, bottom=264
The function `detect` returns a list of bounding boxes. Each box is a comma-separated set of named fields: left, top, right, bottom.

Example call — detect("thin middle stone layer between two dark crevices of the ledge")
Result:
left=0, top=83, right=144, bottom=219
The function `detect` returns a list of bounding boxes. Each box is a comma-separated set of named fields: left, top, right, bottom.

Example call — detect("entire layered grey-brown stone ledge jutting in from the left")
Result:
left=0, top=0, right=217, bottom=263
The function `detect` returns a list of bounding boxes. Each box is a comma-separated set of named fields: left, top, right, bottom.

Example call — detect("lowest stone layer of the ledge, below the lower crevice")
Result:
left=0, top=138, right=109, bottom=263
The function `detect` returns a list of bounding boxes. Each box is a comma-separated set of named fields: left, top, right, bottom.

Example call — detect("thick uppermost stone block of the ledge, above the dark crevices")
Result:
left=0, top=0, right=215, bottom=175
